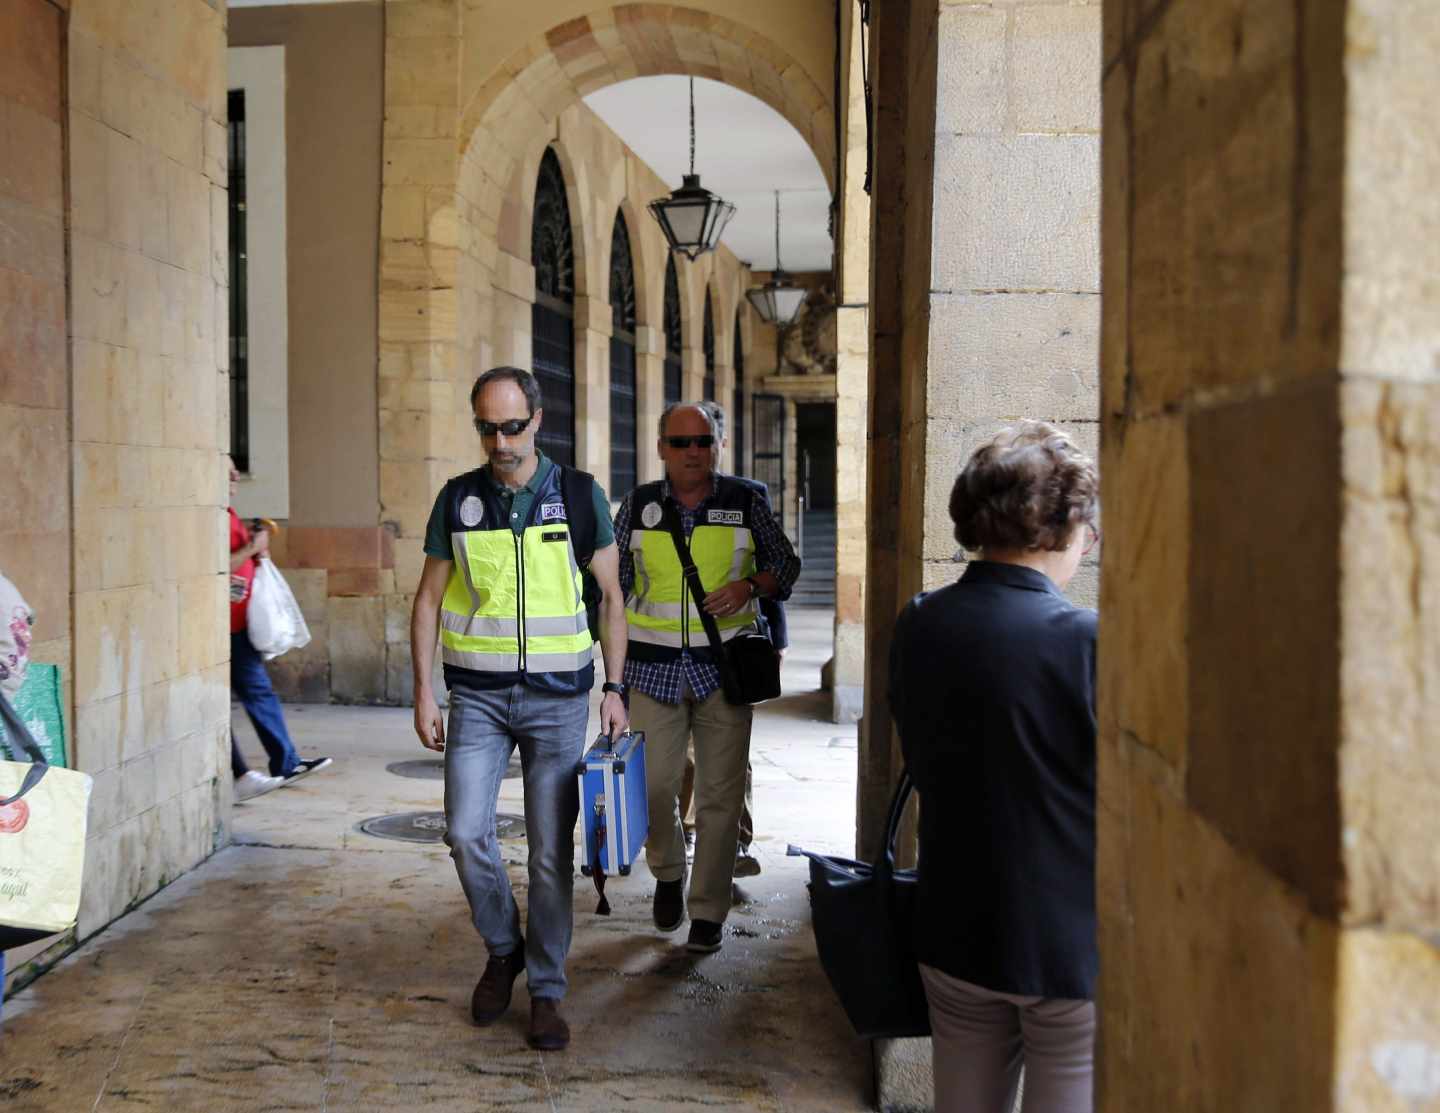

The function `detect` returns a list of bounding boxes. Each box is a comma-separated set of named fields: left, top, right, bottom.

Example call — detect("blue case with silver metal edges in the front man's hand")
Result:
left=575, top=730, right=649, bottom=877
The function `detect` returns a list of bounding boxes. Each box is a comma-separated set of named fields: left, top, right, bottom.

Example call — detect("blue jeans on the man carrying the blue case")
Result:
left=445, top=684, right=590, bottom=999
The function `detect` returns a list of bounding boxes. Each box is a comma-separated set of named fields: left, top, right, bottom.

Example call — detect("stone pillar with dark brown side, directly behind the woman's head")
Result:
left=857, top=0, right=1100, bottom=1109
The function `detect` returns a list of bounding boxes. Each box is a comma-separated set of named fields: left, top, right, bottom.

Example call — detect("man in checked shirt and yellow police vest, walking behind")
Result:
left=615, top=403, right=801, bottom=953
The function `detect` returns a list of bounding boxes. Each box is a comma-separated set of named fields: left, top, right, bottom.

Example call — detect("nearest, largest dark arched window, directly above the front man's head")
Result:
left=530, top=147, right=575, bottom=465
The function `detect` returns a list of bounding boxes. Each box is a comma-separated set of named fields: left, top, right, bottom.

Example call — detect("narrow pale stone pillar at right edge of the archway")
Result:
left=829, top=4, right=870, bottom=723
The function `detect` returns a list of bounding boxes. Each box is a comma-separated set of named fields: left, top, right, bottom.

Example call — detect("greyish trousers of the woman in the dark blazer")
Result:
left=920, top=963, right=1094, bottom=1113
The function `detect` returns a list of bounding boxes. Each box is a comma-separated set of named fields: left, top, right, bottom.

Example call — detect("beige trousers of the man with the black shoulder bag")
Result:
left=631, top=691, right=753, bottom=923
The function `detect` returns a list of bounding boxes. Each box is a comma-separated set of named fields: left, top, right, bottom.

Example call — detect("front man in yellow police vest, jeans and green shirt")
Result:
left=410, top=367, right=628, bottom=1051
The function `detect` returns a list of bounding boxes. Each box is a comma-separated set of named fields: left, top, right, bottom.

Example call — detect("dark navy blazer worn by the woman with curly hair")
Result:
left=890, top=560, right=1099, bottom=999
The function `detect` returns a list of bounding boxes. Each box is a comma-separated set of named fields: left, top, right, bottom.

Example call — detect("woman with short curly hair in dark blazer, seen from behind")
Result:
left=890, top=422, right=1099, bottom=1113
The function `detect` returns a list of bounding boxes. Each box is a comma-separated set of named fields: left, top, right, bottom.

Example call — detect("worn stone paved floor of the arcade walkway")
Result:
left=0, top=612, right=870, bottom=1113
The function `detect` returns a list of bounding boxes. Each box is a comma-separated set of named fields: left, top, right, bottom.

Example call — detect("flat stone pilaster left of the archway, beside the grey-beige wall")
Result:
left=377, top=0, right=468, bottom=700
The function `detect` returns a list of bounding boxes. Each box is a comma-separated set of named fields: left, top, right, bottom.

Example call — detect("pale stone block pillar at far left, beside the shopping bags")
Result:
left=64, top=0, right=230, bottom=939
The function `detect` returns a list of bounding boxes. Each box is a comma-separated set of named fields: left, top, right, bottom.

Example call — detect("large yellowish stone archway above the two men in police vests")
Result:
left=379, top=0, right=835, bottom=573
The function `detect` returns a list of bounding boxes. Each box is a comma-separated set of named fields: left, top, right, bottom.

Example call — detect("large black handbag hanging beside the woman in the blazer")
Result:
left=786, top=773, right=930, bottom=1040
